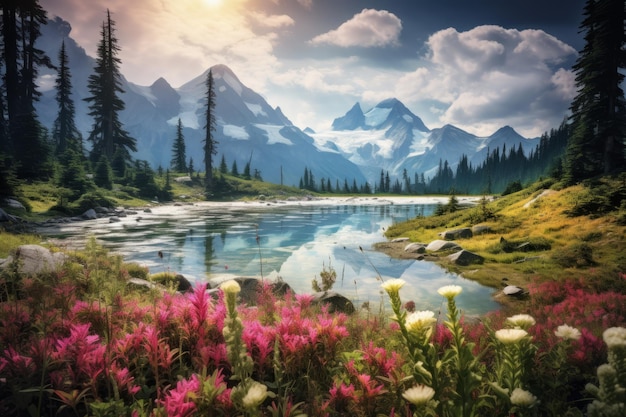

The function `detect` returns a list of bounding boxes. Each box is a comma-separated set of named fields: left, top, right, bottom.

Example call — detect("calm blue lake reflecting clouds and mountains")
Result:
left=41, top=198, right=498, bottom=315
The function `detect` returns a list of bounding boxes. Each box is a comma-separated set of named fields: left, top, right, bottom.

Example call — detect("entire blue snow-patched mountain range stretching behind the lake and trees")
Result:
left=37, top=17, right=538, bottom=185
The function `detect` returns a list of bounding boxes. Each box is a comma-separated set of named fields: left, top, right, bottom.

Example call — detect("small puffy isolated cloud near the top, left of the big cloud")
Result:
left=310, top=9, right=402, bottom=48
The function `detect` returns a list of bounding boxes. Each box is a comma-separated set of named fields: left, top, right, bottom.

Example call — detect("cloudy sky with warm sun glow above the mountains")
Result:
left=40, top=0, right=584, bottom=137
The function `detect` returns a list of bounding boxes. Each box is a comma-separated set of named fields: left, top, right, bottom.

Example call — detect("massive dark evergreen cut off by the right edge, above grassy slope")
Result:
left=564, top=0, right=626, bottom=184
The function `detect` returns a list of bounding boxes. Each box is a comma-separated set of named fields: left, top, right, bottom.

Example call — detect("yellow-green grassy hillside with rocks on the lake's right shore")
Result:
left=378, top=179, right=626, bottom=296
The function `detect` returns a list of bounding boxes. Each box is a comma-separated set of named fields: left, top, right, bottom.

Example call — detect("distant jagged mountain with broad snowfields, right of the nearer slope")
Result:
left=309, top=98, right=538, bottom=182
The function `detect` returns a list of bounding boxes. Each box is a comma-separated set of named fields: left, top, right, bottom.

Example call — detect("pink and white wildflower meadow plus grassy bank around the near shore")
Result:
left=0, top=179, right=626, bottom=417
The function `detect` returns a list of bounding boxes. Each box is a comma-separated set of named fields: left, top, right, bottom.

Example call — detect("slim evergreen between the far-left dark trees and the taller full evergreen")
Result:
left=52, top=41, right=83, bottom=155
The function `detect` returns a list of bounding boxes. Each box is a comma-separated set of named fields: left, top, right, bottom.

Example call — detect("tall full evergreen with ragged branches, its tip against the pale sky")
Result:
left=85, top=10, right=137, bottom=162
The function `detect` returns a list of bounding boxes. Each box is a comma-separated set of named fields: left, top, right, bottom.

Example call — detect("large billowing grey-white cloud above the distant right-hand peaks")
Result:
left=395, top=26, right=576, bottom=135
